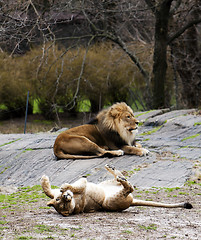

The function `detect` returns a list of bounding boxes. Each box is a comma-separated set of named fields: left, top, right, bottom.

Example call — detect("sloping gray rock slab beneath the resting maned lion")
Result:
left=0, top=109, right=201, bottom=188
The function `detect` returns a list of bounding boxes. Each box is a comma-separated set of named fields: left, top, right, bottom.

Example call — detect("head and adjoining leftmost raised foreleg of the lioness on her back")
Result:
left=41, top=176, right=75, bottom=216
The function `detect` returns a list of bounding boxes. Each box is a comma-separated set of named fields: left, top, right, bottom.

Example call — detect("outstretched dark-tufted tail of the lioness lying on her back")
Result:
left=131, top=199, right=193, bottom=209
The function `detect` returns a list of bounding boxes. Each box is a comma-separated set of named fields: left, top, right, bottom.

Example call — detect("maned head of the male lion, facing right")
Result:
left=97, top=102, right=139, bottom=145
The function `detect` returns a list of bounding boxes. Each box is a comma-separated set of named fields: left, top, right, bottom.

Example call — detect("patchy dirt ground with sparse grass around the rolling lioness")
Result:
left=0, top=182, right=201, bottom=240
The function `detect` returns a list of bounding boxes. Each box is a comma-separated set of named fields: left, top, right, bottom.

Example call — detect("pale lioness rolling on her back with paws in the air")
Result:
left=41, top=165, right=192, bottom=216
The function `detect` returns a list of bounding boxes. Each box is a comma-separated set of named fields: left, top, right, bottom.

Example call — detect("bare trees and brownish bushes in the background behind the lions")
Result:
left=0, top=0, right=201, bottom=123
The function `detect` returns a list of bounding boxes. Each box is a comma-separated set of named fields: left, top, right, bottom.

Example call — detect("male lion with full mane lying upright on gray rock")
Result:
left=54, top=102, right=149, bottom=159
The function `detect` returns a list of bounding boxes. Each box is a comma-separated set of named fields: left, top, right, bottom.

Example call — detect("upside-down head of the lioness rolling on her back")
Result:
left=47, top=190, right=75, bottom=216
